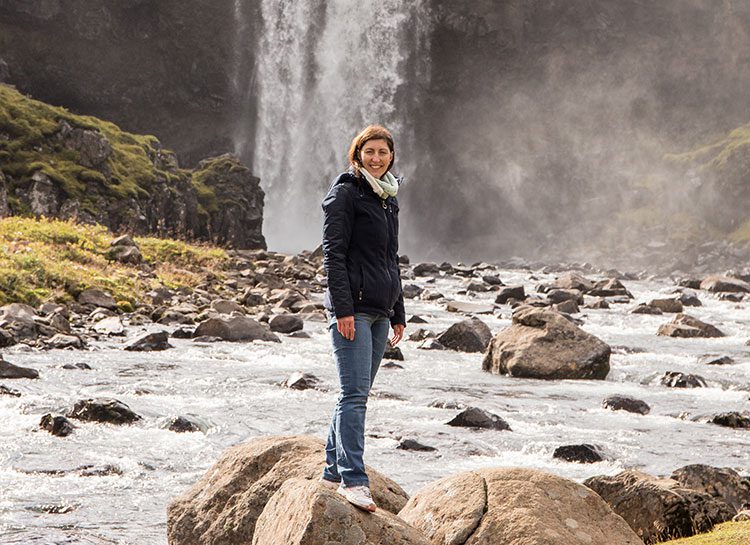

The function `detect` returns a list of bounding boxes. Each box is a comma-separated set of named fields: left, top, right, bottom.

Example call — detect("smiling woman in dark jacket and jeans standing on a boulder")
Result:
left=321, top=125, right=406, bottom=511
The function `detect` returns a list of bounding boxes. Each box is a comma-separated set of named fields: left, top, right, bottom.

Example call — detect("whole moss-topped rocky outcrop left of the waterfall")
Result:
left=0, top=84, right=265, bottom=249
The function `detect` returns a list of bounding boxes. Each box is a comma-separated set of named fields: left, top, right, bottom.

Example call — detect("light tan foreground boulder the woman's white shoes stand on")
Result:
left=252, top=479, right=430, bottom=545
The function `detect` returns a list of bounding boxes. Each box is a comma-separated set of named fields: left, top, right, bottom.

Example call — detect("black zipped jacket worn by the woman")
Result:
left=323, top=171, right=406, bottom=325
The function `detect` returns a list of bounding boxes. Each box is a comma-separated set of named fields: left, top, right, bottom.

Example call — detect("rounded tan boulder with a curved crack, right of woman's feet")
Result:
left=399, top=468, right=642, bottom=545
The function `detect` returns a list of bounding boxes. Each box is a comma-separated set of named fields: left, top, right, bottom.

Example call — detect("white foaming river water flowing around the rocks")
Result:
left=0, top=271, right=750, bottom=544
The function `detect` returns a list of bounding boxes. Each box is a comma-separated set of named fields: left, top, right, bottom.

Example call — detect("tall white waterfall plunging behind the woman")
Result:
left=250, top=0, right=428, bottom=251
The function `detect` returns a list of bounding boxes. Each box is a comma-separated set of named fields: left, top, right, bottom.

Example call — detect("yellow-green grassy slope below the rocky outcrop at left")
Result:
left=0, top=217, right=229, bottom=309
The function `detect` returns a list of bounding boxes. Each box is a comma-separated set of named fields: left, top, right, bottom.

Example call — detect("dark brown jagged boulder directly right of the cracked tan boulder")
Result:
left=583, top=469, right=735, bottom=544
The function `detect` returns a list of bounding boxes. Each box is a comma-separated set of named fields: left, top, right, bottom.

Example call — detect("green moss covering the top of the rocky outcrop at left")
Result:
left=0, top=84, right=197, bottom=215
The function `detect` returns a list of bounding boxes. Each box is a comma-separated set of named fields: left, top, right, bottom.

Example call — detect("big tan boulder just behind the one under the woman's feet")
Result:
left=167, top=436, right=407, bottom=545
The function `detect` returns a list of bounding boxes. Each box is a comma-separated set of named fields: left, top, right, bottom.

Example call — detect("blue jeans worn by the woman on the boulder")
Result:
left=323, top=313, right=390, bottom=486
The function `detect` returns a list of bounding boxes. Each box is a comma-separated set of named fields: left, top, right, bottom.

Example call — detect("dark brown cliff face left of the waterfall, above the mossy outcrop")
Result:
left=0, top=0, right=253, bottom=165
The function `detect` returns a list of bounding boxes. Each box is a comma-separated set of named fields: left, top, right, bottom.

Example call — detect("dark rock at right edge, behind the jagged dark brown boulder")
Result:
left=671, top=464, right=750, bottom=511
